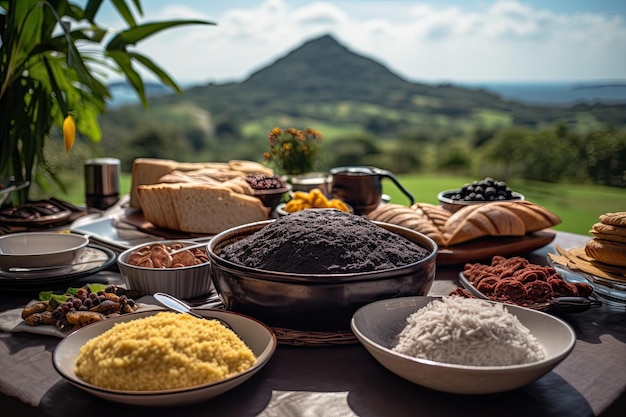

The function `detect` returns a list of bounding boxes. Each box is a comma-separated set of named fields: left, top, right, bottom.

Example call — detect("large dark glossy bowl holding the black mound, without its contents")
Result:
left=208, top=220, right=438, bottom=331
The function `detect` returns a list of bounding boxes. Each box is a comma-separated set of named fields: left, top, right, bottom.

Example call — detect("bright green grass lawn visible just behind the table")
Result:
left=61, top=174, right=626, bottom=235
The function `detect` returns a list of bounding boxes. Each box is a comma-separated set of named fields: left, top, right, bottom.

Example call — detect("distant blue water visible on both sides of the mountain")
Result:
left=109, top=81, right=626, bottom=107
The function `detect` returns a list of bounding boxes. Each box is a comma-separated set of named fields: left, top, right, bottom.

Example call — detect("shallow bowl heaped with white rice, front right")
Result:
left=350, top=296, right=576, bottom=394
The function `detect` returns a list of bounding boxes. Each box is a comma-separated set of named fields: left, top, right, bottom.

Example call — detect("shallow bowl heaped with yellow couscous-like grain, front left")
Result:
left=52, top=310, right=276, bottom=406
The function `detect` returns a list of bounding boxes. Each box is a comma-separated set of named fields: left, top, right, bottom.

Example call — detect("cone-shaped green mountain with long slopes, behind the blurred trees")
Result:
left=155, top=35, right=626, bottom=125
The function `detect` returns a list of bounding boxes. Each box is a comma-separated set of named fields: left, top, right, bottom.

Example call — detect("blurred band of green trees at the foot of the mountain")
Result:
left=35, top=116, right=626, bottom=204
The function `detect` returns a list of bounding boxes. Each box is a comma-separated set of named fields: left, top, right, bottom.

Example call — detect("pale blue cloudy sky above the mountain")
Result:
left=99, top=0, right=626, bottom=83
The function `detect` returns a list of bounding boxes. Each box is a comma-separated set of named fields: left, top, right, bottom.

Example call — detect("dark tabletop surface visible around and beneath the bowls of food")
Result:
left=0, top=232, right=626, bottom=417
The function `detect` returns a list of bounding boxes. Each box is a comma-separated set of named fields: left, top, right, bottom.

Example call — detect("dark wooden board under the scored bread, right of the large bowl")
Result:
left=437, top=230, right=556, bottom=265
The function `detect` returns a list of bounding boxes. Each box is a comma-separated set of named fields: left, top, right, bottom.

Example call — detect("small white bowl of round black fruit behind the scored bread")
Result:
left=437, top=177, right=524, bottom=213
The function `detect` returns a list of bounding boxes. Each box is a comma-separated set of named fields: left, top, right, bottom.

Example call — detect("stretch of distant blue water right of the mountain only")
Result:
left=458, top=82, right=626, bottom=106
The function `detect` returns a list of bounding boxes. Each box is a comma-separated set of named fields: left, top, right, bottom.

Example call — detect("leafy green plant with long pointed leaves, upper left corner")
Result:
left=0, top=0, right=214, bottom=203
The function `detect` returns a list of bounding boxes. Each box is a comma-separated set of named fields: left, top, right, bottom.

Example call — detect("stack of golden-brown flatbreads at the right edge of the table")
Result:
left=548, top=212, right=626, bottom=283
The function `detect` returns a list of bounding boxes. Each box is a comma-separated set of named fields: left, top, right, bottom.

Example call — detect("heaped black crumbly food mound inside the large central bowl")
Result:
left=220, top=209, right=430, bottom=274
